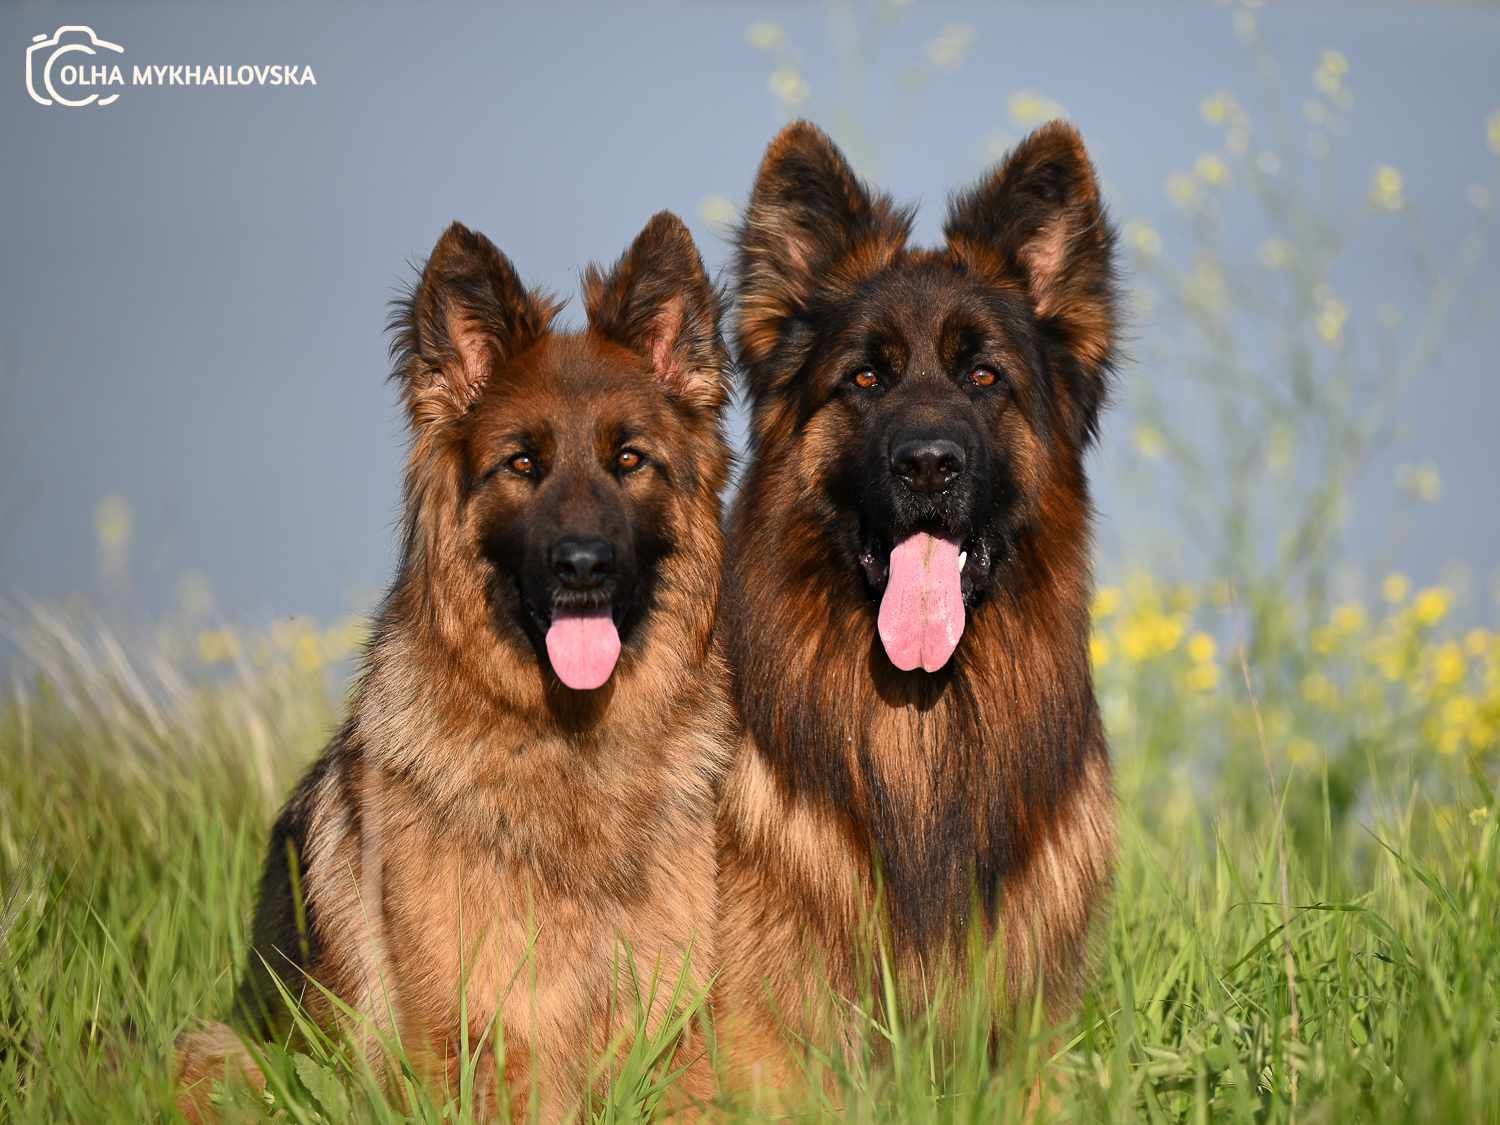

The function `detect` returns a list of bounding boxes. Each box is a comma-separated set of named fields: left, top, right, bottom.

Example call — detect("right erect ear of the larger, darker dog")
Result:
left=944, top=122, right=1116, bottom=377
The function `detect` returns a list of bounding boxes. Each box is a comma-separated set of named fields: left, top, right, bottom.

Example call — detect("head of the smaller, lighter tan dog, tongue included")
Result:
left=395, top=213, right=728, bottom=692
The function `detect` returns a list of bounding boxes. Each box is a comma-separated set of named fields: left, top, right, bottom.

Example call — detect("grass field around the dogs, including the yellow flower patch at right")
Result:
left=0, top=579, right=1500, bottom=1122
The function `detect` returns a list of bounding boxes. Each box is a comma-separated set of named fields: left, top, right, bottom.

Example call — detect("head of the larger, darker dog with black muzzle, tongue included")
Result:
left=738, top=123, right=1116, bottom=672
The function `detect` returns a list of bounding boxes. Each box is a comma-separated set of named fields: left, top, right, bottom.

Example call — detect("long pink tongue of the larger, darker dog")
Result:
left=881, top=533, right=963, bottom=672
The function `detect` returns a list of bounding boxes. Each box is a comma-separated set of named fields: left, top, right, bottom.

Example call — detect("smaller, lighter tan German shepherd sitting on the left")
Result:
left=179, top=213, right=732, bottom=1119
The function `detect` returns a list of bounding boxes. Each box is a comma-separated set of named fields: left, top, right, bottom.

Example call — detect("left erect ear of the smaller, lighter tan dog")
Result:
left=390, top=222, right=558, bottom=428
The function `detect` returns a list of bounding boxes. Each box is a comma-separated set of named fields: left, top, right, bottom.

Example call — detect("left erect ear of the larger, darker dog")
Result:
left=737, top=122, right=912, bottom=393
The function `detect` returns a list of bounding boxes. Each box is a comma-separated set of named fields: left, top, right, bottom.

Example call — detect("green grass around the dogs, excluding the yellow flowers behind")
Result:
left=0, top=612, right=1500, bottom=1124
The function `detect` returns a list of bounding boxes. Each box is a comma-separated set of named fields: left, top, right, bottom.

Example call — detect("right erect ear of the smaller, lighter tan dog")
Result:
left=584, top=212, right=729, bottom=411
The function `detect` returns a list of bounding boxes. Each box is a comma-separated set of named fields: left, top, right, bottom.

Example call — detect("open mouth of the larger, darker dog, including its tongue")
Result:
left=860, top=531, right=989, bottom=672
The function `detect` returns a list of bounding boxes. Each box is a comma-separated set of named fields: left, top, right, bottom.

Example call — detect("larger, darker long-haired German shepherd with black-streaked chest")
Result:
left=717, top=123, right=1116, bottom=1083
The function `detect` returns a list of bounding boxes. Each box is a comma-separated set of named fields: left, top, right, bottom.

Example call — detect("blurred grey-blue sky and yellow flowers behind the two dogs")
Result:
left=0, top=0, right=1500, bottom=822
